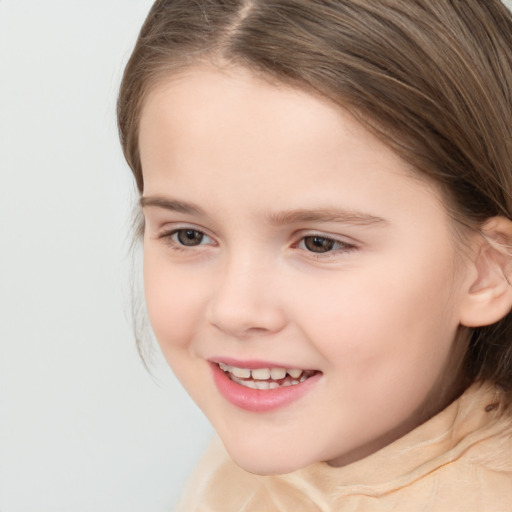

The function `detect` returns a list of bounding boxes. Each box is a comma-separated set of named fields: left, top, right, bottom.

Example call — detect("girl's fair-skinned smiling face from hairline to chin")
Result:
left=140, top=66, right=474, bottom=474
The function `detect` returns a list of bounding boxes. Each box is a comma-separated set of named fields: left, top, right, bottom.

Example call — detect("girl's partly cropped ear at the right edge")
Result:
left=460, top=217, right=512, bottom=327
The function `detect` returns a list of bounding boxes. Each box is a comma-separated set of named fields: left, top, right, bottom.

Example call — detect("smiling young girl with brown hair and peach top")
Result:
left=118, top=0, right=512, bottom=512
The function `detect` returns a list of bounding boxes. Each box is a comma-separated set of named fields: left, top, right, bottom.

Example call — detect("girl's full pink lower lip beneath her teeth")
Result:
left=211, top=363, right=321, bottom=412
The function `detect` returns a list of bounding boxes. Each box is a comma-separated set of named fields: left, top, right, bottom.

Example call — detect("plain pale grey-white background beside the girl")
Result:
left=0, top=0, right=511, bottom=512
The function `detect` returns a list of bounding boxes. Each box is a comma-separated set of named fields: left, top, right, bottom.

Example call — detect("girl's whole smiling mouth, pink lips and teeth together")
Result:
left=210, top=360, right=323, bottom=412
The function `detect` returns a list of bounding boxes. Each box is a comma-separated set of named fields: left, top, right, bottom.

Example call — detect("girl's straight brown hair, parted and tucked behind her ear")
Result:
left=118, top=0, right=512, bottom=391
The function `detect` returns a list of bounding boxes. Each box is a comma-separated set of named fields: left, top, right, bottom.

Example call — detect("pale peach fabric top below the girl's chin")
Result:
left=176, top=384, right=512, bottom=512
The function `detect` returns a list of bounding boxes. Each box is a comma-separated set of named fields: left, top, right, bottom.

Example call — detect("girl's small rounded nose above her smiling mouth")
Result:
left=207, top=251, right=286, bottom=338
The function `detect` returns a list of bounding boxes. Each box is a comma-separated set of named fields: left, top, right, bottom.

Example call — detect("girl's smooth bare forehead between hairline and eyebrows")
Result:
left=139, top=66, right=448, bottom=224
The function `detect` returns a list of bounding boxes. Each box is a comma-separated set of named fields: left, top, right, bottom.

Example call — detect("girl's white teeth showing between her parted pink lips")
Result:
left=218, top=363, right=318, bottom=390
